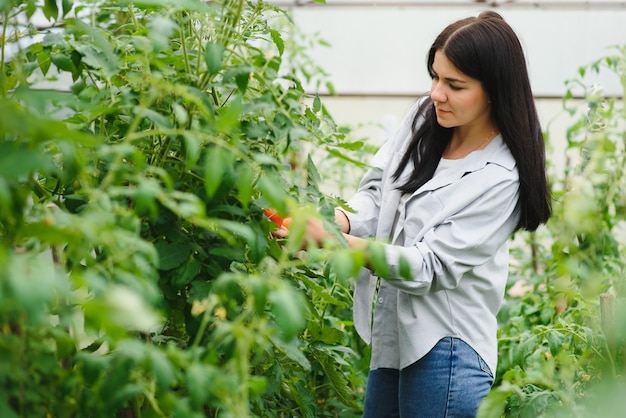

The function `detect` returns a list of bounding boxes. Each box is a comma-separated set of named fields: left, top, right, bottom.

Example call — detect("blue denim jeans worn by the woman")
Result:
left=363, top=337, right=493, bottom=418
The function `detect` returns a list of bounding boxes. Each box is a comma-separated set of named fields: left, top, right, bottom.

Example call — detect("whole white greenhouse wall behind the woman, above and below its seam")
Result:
left=276, top=0, right=626, bottom=192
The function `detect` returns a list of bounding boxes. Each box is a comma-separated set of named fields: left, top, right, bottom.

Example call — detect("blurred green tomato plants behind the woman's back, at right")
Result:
left=481, top=47, right=626, bottom=417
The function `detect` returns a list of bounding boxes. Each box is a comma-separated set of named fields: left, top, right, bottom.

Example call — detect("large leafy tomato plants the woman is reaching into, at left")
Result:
left=0, top=0, right=367, bottom=417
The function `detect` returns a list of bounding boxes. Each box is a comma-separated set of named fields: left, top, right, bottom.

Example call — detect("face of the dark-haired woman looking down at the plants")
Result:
left=430, top=51, right=491, bottom=128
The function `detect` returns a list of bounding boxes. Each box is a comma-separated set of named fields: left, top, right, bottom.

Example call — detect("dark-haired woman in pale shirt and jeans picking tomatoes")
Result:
left=279, top=12, right=551, bottom=418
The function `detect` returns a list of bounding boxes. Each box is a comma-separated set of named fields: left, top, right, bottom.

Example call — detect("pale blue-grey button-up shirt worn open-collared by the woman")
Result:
left=345, top=103, right=519, bottom=374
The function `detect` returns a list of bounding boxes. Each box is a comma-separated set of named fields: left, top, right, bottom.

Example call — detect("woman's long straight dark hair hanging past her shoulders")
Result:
left=394, top=11, right=551, bottom=231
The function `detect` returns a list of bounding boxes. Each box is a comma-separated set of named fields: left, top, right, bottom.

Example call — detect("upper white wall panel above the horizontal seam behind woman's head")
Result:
left=285, top=5, right=626, bottom=97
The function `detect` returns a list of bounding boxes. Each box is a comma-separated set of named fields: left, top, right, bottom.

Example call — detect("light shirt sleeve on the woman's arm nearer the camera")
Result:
left=378, top=168, right=519, bottom=295
